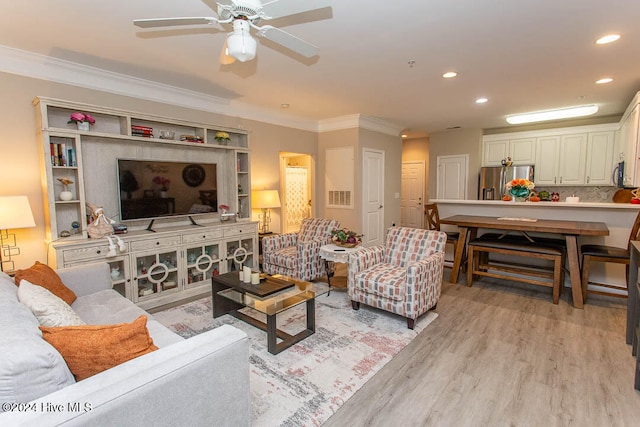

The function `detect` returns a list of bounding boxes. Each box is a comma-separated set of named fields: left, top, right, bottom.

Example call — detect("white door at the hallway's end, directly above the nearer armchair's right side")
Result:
left=400, top=162, right=425, bottom=228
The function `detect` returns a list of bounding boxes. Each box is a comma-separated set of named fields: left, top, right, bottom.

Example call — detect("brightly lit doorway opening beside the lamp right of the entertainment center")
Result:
left=280, top=152, right=314, bottom=233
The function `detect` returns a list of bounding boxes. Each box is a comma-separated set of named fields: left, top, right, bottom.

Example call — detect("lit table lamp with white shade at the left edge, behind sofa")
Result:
left=0, top=196, right=36, bottom=271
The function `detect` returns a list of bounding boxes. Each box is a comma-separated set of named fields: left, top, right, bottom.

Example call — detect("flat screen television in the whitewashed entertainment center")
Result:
left=118, top=159, right=218, bottom=220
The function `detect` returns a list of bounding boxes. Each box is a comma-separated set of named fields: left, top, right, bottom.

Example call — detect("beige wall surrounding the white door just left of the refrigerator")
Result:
left=428, top=129, right=482, bottom=199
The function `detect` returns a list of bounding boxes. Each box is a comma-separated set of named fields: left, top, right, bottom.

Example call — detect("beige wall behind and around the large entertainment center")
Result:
left=0, top=73, right=318, bottom=268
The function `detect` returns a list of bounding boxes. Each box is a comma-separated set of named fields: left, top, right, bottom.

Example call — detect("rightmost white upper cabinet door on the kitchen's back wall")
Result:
left=585, top=131, right=615, bottom=185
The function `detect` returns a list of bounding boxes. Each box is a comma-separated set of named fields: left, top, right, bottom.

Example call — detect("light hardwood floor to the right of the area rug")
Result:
left=324, top=269, right=640, bottom=427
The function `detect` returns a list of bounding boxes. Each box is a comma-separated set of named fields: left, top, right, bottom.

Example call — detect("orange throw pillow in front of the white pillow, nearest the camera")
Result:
left=40, top=315, right=158, bottom=381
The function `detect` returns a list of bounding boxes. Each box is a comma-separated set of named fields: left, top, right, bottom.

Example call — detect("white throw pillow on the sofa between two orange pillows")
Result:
left=18, top=279, right=85, bottom=326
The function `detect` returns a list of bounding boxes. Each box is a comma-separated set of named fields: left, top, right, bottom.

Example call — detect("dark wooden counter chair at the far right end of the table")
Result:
left=580, top=213, right=640, bottom=298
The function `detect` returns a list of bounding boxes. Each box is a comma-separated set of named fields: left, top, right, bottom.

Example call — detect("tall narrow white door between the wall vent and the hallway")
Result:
left=362, top=149, right=384, bottom=246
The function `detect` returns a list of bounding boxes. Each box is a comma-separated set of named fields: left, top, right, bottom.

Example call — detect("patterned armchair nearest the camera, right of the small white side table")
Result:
left=348, top=227, right=447, bottom=329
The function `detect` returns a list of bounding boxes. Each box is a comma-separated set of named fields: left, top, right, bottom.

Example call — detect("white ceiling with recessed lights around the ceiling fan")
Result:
left=0, top=0, right=640, bottom=134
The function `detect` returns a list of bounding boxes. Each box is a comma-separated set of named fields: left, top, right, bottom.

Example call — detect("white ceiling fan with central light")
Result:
left=133, top=0, right=331, bottom=64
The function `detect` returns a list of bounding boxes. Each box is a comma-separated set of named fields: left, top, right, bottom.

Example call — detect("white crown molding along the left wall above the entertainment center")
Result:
left=0, top=45, right=318, bottom=132
